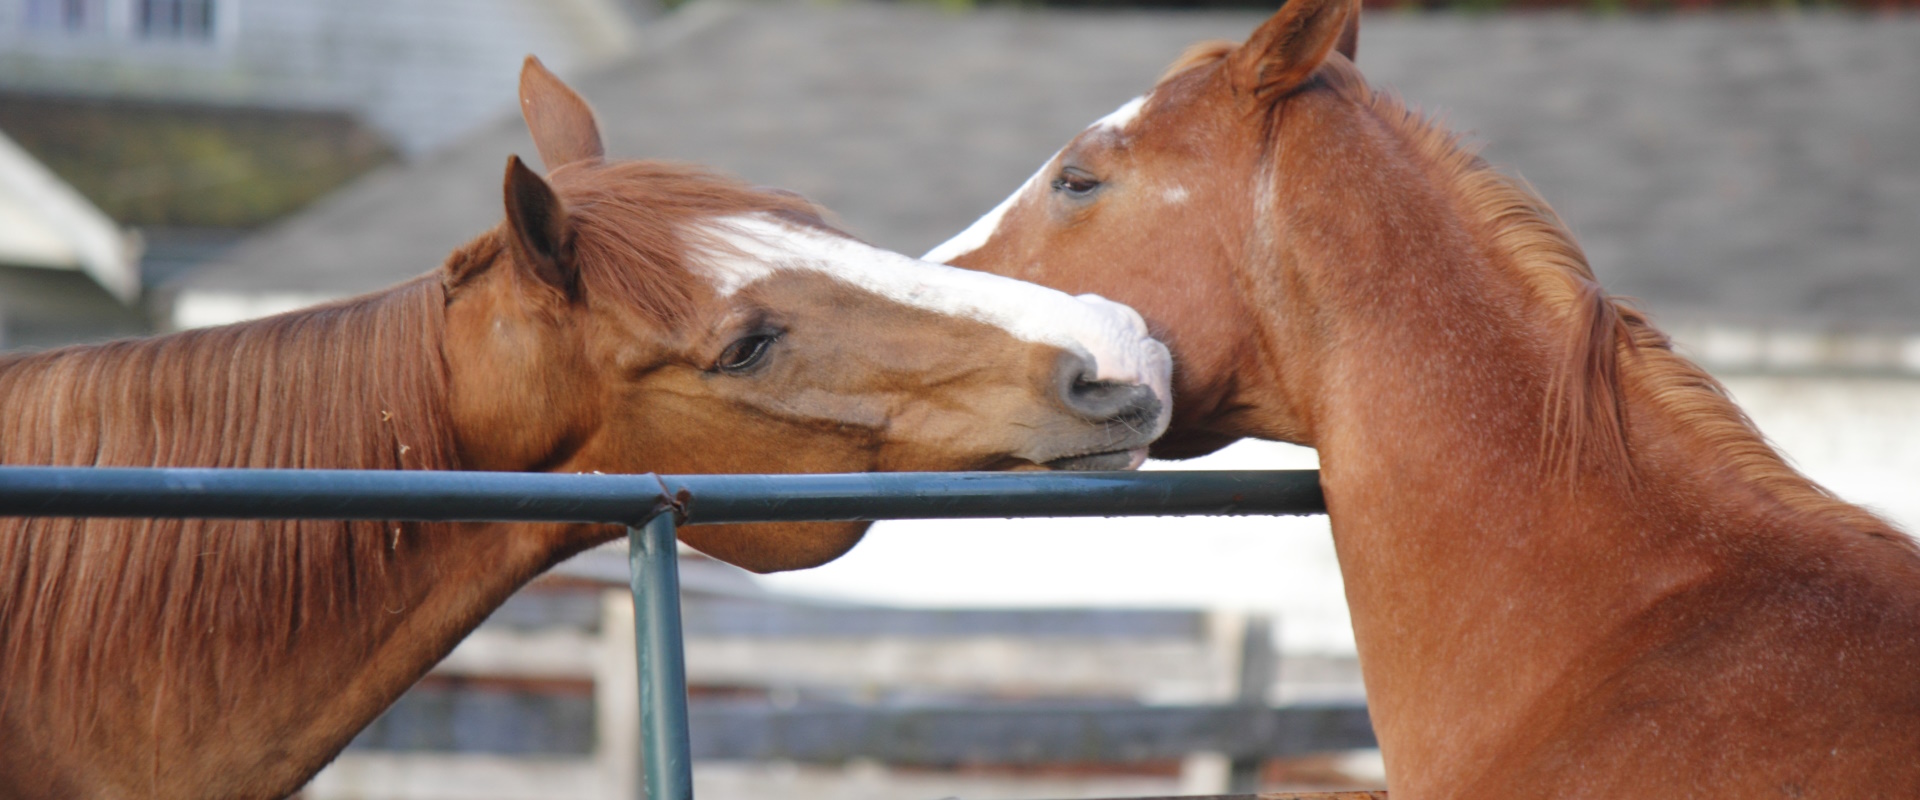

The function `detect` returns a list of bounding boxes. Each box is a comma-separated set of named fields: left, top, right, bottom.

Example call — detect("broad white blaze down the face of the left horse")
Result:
left=703, top=215, right=1173, bottom=437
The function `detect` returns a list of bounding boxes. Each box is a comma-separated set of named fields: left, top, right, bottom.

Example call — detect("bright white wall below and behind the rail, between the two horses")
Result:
left=762, top=441, right=1354, bottom=654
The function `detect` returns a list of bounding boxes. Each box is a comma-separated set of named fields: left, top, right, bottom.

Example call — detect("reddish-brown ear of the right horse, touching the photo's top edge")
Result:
left=1233, top=0, right=1359, bottom=100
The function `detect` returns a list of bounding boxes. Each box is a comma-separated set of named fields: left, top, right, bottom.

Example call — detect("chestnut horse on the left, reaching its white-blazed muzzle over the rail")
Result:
left=0, top=59, right=1169, bottom=798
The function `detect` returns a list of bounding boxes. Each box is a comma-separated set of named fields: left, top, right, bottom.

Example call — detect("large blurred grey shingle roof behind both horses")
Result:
left=184, top=0, right=1920, bottom=330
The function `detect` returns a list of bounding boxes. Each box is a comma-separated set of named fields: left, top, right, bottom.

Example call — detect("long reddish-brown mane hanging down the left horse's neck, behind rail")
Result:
left=0, top=274, right=459, bottom=731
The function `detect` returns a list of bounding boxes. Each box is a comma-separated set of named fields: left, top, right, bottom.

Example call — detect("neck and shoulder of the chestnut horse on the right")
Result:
left=1238, top=70, right=1920, bottom=798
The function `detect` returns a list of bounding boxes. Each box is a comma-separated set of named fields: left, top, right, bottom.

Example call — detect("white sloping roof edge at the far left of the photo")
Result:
left=0, top=127, right=140, bottom=303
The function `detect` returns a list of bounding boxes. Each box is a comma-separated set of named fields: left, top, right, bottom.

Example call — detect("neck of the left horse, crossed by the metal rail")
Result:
left=0, top=282, right=580, bottom=794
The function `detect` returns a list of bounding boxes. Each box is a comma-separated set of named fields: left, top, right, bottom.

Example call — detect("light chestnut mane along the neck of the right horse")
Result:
left=1160, top=42, right=1916, bottom=549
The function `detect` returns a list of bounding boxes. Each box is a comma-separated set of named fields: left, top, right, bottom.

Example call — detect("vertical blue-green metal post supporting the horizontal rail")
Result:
left=626, top=512, right=693, bottom=800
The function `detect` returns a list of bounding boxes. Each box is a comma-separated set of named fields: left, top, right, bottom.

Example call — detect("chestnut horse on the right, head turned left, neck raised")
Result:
left=927, top=0, right=1920, bottom=800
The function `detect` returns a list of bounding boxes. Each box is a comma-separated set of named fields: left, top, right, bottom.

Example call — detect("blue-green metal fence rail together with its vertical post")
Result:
left=0, top=466, right=1325, bottom=800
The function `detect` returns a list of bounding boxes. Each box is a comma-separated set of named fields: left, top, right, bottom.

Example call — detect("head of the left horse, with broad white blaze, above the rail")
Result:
left=445, top=59, right=1171, bottom=572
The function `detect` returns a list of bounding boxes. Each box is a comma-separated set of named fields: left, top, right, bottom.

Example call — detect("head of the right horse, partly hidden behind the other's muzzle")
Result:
left=925, top=0, right=1359, bottom=459
